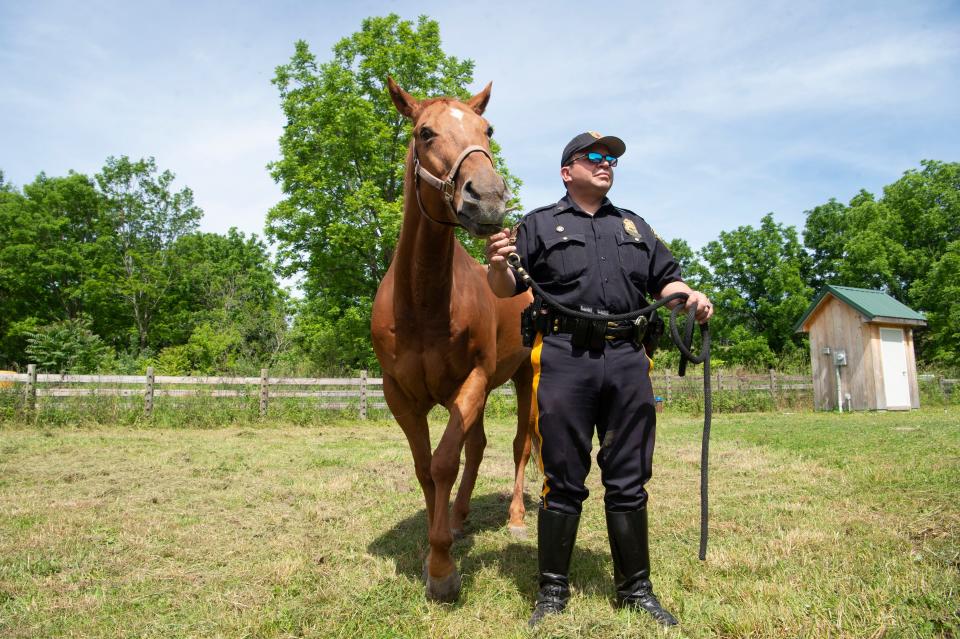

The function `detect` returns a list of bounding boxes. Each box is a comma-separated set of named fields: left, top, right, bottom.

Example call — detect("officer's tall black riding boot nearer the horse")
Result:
left=528, top=508, right=580, bottom=627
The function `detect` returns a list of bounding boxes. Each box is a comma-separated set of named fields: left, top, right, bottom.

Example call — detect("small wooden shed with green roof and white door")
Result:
left=795, top=284, right=927, bottom=410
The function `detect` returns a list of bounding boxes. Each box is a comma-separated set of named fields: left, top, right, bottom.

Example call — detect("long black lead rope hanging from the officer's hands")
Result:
left=507, top=253, right=713, bottom=561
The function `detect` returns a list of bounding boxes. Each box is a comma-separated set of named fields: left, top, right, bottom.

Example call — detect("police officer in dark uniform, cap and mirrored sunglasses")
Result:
left=486, top=132, right=713, bottom=626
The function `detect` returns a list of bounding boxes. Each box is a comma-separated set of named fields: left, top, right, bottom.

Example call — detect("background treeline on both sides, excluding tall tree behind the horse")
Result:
left=0, top=157, right=960, bottom=374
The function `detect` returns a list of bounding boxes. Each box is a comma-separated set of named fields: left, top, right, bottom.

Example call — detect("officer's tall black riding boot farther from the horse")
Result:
left=607, top=508, right=677, bottom=626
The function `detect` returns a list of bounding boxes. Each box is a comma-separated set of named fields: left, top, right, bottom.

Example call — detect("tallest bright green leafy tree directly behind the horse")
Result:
left=267, top=14, right=518, bottom=370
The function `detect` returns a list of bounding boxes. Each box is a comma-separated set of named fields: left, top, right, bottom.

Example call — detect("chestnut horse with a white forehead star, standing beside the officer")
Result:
left=371, top=78, right=533, bottom=601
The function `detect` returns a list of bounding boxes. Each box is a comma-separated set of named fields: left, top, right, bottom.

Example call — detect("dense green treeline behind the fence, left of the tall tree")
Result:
left=0, top=157, right=291, bottom=374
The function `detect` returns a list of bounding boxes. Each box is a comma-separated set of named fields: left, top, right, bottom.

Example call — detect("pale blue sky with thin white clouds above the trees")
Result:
left=0, top=0, right=960, bottom=255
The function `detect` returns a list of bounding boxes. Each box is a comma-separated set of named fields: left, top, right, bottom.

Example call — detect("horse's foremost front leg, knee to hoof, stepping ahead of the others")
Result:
left=427, top=368, right=487, bottom=602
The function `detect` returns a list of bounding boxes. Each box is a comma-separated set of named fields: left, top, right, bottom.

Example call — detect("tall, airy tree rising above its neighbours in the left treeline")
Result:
left=97, top=156, right=203, bottom=351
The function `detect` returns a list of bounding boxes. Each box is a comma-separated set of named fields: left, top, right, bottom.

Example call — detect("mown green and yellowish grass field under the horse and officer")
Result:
left=0, top=407, right=960, bottom=638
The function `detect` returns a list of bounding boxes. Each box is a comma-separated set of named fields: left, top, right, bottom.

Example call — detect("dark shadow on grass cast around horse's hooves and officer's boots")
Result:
left=368, top=493, right=612, bottom=603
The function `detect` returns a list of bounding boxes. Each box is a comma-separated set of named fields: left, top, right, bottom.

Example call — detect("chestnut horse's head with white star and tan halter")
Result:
left=387, top=78, right=511, bottom=237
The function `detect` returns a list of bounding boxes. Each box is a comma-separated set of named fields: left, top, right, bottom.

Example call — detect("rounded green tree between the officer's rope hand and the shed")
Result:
left=701, top=213, right=812, bottom=364
